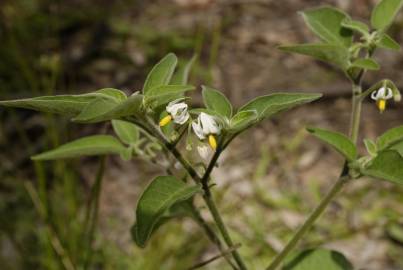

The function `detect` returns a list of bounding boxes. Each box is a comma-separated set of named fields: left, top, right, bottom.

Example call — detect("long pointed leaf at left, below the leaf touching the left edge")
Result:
left=32, top=135, right=126, bottom=160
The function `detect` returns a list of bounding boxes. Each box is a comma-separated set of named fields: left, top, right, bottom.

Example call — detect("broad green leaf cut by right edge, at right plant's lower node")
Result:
left=362, top=150, right=403, bottom=184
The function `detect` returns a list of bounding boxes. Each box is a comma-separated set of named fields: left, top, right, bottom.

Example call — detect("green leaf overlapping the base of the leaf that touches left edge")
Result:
left=72, top=92, right=143, bottom=123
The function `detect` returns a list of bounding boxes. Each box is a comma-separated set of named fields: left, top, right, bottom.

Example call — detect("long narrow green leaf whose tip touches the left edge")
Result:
left=0, top=93, right=99, bottom=116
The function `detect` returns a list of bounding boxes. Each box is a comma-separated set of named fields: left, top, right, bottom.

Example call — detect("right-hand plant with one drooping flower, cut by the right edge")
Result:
left=268, top=0, right=403, bottom=270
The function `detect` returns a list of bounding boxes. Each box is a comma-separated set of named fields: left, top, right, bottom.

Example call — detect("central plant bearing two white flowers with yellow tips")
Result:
left=0, top=53, right=321, bottom=269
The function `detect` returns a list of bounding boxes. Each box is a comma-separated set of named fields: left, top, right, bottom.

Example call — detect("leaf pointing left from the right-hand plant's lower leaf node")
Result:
left=307, top=128, right=357, bottom=161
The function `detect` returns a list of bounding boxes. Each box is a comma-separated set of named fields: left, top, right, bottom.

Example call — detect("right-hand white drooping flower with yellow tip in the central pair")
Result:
left=192, top=112, right=221, bottom=150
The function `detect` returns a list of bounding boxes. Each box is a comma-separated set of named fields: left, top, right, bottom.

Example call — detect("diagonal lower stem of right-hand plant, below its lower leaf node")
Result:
left=267, top=177, right=348, bottom=270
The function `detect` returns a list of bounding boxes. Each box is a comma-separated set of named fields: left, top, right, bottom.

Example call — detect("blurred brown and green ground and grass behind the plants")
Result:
left=0, top=0, right=403, bottom=270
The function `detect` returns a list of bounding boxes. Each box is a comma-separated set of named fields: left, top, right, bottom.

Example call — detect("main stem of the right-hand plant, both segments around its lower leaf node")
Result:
left=267, top=79, right=364, bottom=270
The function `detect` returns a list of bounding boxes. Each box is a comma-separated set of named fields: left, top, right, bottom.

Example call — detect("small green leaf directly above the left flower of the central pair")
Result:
left=144, top=85, right=195, bottom=107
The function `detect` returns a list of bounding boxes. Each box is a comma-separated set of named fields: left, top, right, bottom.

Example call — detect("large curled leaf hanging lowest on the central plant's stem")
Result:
left=133, top=176, right=202, bottom=247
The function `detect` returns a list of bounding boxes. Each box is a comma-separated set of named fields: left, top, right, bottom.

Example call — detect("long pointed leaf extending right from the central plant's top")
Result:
left=238, top=93, right=322, bottom=121
